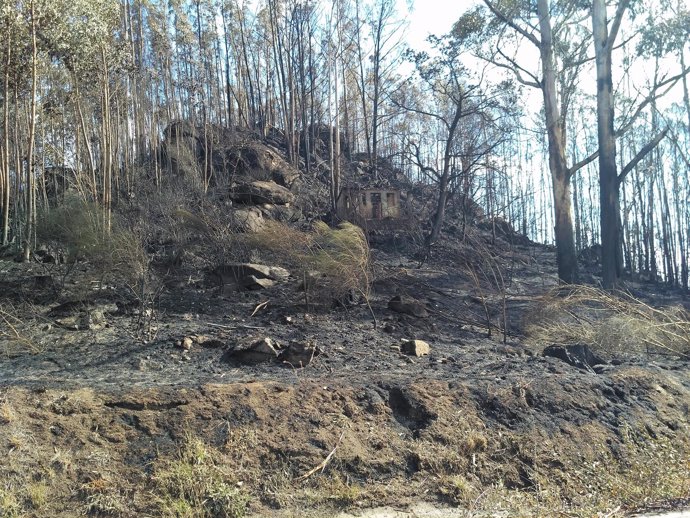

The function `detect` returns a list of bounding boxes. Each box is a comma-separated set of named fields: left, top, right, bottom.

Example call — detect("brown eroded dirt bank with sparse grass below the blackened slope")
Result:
left=0, top=368, right=690, bottom=516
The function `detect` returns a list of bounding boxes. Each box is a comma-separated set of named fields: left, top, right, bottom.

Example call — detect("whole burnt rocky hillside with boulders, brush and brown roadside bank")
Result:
left=0, top=124, right=690, bottom=517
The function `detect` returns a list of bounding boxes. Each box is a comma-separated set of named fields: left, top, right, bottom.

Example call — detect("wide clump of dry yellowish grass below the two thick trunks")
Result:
left=527, top=286, right=690, bottom=357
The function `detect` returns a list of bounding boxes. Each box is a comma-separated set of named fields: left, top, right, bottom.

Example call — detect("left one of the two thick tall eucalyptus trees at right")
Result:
left=454, top=0, right=595, bottom=283
